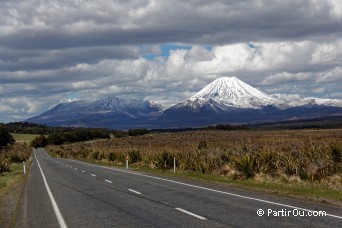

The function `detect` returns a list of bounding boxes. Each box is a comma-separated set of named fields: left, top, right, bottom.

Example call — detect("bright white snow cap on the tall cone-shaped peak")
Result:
left=184, top=77, right=284, bottom=109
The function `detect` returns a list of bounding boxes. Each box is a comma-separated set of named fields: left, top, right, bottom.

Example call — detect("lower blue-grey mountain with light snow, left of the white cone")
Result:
left=26, top=97, right=163, bottom=128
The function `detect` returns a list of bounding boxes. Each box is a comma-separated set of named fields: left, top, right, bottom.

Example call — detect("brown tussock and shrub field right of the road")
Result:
left=48, top=129, right=342, bottom=203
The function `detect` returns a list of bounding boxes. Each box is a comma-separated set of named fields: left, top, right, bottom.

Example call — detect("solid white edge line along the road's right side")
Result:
left=59, top=155, right=342, bottom=219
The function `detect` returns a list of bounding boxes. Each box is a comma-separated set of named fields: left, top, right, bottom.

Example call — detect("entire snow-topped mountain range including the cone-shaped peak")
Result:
left=26, top=77, right=342, bottom=129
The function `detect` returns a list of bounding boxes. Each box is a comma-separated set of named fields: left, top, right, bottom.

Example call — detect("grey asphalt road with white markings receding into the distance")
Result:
left=16, top=149, right=342, bottom=228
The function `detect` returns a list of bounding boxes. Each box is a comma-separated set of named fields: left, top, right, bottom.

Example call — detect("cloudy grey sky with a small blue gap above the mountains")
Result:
left=0, top=0, right=342, bottom=122
